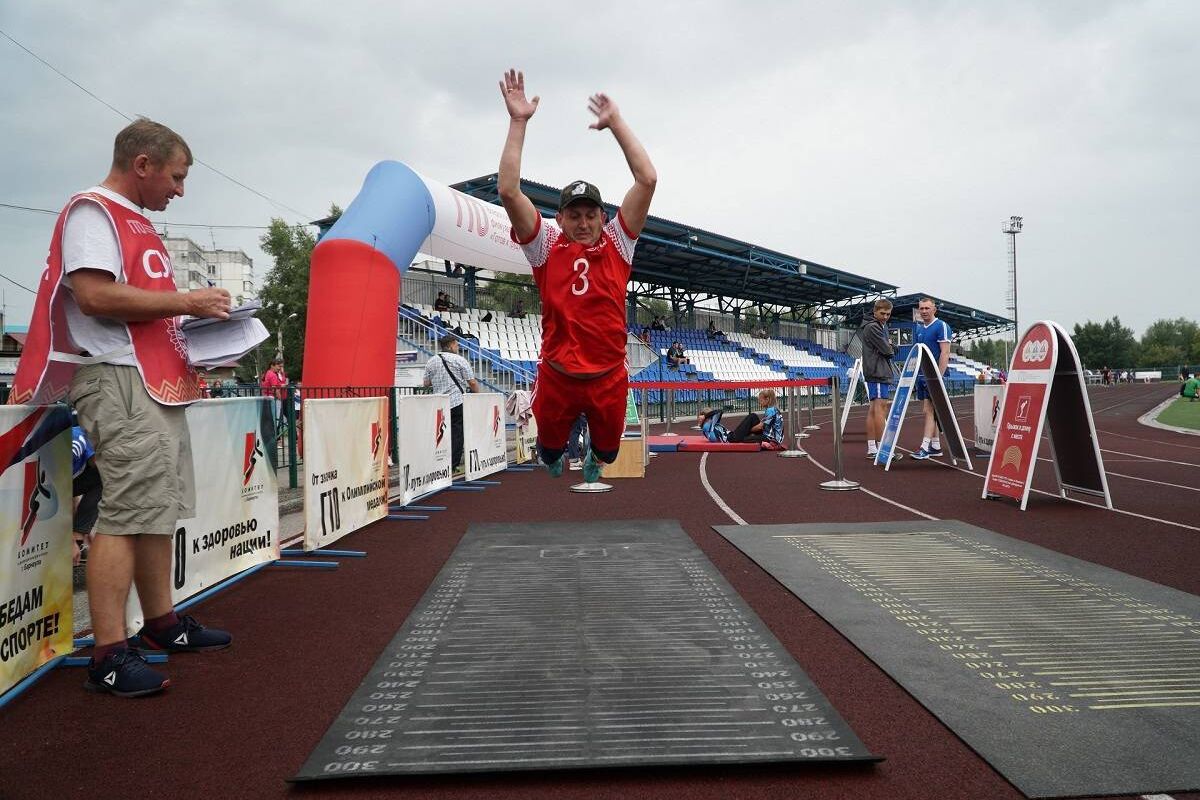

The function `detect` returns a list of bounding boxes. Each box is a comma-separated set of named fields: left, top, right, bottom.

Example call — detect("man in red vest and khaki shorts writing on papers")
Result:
left=10, top=119, right=232, bottom=697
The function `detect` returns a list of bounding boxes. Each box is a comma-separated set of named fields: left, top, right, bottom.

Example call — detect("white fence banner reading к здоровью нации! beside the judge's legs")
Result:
left=125, top=397, right=280, bottom=633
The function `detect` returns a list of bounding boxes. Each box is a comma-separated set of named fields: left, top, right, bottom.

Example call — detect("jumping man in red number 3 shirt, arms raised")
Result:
left=498, top=70, right=658, bottom=482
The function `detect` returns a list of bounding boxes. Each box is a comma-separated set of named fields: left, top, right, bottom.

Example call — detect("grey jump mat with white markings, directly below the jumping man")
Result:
left=294, top=521, right=877, bottom=781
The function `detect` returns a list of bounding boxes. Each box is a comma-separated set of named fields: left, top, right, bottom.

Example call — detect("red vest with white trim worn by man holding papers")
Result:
left=8, top=192, right=200, bottom=405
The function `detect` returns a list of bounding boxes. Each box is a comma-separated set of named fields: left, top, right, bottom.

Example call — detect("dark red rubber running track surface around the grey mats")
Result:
left=0, top=385, right=1200, bottom=800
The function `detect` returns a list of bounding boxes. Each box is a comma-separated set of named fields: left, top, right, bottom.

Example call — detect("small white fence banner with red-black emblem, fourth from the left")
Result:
left=397, top=395, right=451, bottom=505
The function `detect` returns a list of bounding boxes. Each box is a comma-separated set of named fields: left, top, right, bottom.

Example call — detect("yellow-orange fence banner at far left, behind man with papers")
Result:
left=0, top=405, right=73, bottom=694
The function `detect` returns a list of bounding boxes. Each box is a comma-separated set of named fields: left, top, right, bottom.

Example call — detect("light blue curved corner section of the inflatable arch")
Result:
left=320, top=161, right=437, bottom=275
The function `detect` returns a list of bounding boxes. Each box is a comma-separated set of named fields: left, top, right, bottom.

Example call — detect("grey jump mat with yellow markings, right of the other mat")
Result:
left=716, top=521, right=1200, bottom=798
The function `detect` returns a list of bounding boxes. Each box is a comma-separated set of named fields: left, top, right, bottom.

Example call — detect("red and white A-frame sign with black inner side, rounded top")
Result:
left=983, top=320, right=1112, bottom=511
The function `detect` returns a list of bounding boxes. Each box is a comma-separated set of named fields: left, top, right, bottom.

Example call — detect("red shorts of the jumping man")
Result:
left=533, top=363, right=629, bottom=453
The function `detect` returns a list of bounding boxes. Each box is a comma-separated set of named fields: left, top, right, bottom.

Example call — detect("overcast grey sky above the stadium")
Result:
left=0, top=0, right=1200, bottom=336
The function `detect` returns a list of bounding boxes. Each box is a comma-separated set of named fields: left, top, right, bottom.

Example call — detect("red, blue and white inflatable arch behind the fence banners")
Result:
left=304, top=161, right=529, bottom=386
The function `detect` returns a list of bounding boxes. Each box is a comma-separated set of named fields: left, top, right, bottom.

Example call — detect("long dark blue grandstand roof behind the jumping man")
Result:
left=454, top=175, right=896, bottom=308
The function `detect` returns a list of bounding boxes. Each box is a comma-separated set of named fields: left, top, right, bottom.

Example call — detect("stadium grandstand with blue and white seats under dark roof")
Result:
left=388, top=175, right=1013, bottom=403
